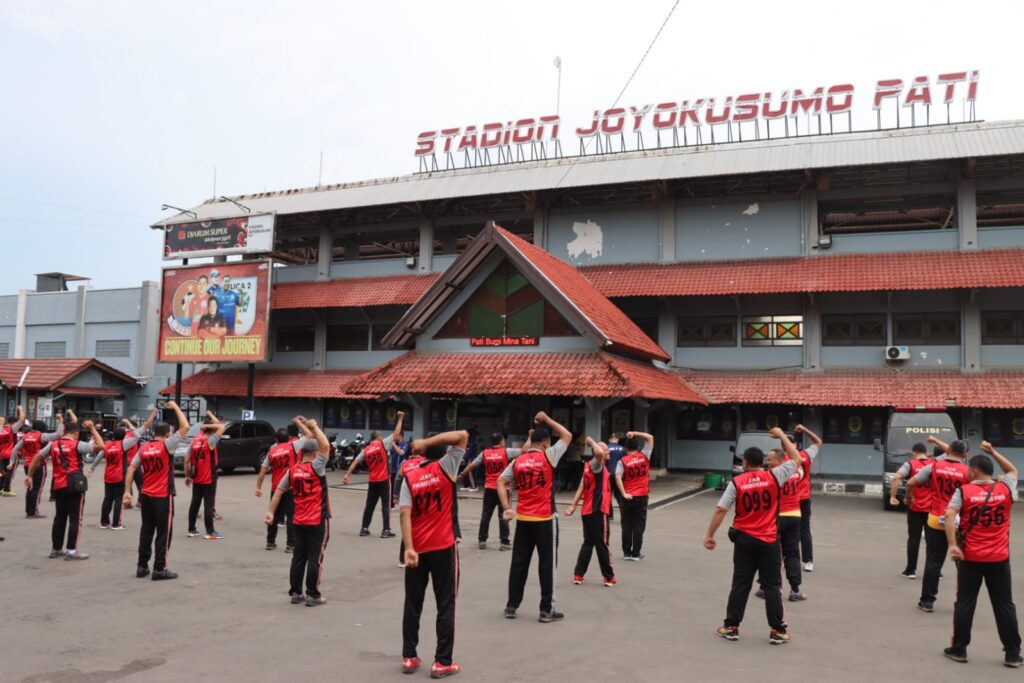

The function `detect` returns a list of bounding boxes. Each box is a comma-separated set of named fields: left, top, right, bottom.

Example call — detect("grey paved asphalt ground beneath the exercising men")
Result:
left=0, top=472, right=1024, bottom=683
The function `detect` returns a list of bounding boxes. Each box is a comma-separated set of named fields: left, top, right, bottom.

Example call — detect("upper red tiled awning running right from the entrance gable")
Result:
left=583, top=249, right=1024, bottom=297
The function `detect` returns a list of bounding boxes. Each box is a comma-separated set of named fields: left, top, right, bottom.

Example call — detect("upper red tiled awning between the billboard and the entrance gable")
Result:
left=270, top=273, right=437, bottom=310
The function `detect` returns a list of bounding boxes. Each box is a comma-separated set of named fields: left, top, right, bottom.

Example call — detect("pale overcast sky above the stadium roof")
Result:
left=0, top=0, right=1024, bottom=293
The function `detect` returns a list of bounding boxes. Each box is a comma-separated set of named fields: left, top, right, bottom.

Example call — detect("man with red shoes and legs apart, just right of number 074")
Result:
left=565, top=436, right=618, bottom=588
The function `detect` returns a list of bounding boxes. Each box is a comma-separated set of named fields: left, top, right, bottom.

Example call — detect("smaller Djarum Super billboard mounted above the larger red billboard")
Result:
left=164, top=213, right=273, bottom=261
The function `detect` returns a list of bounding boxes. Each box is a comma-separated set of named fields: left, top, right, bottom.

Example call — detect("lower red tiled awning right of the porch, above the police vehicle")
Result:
left=681, top=370, right=1024, bottom=409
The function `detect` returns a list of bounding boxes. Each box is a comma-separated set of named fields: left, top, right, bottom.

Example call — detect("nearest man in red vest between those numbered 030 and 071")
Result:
left=263, top=420, right=331, bottom=607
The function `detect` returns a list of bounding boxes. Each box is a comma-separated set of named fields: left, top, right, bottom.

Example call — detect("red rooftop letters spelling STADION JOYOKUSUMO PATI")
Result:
left=415, top=71, right=979, bottom=170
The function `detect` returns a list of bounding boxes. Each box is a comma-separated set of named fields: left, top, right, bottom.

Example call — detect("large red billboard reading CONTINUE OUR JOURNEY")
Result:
left=160, top=261, right=270, bottom=362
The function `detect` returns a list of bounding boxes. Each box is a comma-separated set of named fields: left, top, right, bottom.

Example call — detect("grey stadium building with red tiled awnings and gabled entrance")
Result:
left=155, top=121, right=1024, bottom=477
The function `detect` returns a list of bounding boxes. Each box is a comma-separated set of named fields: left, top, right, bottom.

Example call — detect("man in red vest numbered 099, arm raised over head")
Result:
left=703, top=427, right=800, bottom=645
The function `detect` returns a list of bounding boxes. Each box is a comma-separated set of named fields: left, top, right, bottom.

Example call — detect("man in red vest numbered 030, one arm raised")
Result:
left=123, top=400, right=188, bottom=581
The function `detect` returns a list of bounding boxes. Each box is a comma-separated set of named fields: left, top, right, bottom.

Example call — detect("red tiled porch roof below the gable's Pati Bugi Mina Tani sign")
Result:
left=348, top=351, right=707, bottom=403
